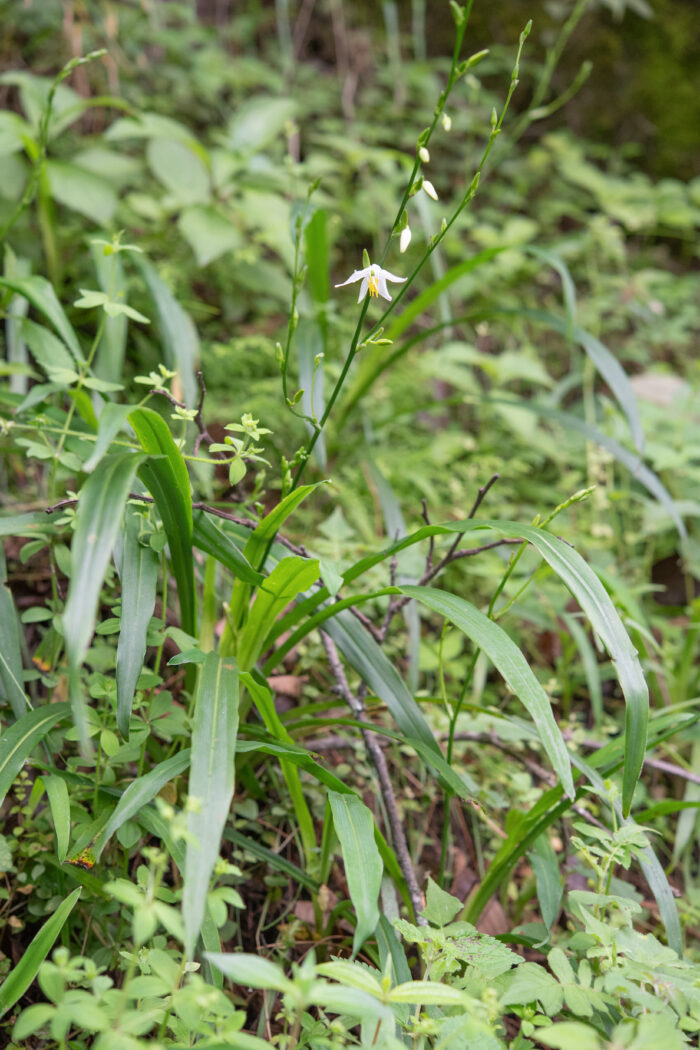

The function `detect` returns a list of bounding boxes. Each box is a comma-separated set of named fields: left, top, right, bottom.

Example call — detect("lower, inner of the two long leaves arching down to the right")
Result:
left=399, top=592, right=574, bottom=798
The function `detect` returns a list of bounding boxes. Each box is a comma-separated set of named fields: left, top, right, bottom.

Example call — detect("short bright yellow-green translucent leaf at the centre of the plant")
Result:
left=236, top=555, right=319, bottom=671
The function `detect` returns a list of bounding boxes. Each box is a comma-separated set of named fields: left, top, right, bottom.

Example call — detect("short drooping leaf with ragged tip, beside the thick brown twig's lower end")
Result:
left=328, top=792, right=384, bottom=958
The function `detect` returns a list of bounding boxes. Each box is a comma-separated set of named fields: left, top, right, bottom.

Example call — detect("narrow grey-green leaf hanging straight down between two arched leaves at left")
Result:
left=116, top=507, right=158, bottom=737
